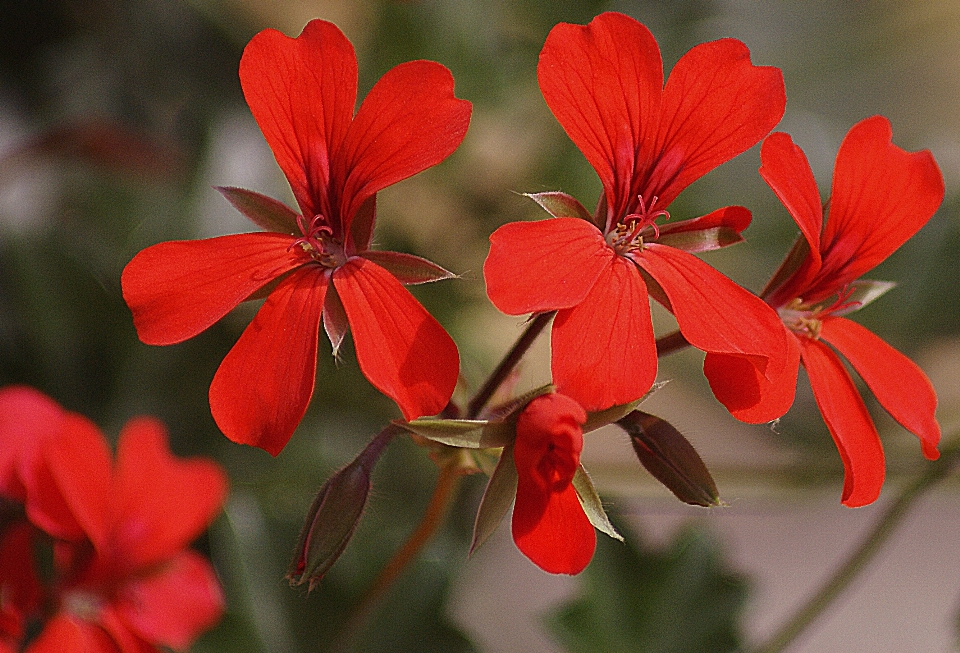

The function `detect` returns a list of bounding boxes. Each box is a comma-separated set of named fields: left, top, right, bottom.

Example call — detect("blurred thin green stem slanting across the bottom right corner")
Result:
left=750, top=444, right=960, bottom=653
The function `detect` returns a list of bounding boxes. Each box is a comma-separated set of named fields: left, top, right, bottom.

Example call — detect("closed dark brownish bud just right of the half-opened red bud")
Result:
left=617, top=410, right=723, bottom=507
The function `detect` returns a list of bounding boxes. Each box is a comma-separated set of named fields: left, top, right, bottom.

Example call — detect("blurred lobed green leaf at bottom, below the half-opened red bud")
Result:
left=547, top=528, right=747, bottom=653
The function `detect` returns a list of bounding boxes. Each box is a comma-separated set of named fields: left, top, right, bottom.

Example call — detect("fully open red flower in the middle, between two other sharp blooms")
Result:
left=484, top=13, right=786, bottom=410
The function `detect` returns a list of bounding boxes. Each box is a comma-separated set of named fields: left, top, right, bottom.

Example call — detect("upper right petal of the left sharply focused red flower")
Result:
left=331, top=61, right=471, bottom=239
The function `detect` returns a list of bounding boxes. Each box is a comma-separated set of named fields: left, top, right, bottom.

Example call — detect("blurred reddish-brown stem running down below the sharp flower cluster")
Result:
left=332, top=458, right=466, bottom=651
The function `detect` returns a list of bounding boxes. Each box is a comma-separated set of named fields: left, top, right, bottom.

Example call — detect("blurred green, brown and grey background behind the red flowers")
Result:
left=0, top=0, right=960, bottom=653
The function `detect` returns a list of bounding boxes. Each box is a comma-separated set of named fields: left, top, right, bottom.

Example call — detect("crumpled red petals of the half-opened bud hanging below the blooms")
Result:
left=513, top=393, right=597, bottom=574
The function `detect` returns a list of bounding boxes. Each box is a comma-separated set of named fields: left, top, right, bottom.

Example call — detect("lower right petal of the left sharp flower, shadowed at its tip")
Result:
left=333, top=258, right=460, bottom=421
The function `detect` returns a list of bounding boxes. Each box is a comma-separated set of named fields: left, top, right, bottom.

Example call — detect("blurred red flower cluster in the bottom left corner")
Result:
left=0, top=386, right=227, bottom=653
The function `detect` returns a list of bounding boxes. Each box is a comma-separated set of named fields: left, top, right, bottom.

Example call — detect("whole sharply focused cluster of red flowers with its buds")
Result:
left=122, top=13, right=944, bottom=584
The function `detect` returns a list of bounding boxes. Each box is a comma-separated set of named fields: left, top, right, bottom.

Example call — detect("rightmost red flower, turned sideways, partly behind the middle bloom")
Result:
left=704, top=116, right=944, bottom=506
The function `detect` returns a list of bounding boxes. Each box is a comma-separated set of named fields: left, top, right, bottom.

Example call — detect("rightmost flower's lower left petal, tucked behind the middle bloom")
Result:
left=703, top=326, right=800, bottom=424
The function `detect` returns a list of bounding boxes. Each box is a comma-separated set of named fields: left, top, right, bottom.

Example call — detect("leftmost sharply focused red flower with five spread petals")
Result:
left=122, top=20, right=470, bottom=455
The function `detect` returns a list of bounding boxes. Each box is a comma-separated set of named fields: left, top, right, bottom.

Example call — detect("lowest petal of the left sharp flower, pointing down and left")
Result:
left=210, top=265, right=328, bottom=456
